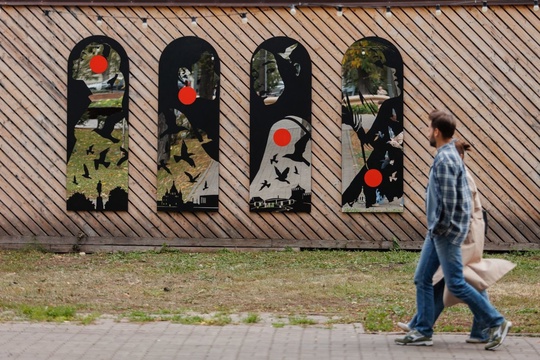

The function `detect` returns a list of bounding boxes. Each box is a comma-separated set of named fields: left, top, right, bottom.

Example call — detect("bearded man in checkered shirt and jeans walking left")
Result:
left=395, top=110, right=512, bottom=350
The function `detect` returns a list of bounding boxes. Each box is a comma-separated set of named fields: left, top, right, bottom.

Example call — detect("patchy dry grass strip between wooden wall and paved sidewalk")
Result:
left=0, top=250, right=540, bottom=334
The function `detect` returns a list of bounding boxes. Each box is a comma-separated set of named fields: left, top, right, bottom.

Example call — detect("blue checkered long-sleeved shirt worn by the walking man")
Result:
left=426, top=141, right=472, bottom=245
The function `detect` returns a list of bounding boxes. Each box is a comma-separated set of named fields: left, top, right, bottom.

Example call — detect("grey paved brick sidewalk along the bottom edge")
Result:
left=0, top=319, right=540, bottom=360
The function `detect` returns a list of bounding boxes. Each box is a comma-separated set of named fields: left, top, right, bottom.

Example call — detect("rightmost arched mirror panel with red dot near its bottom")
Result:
left=342, top=37, right=403, bottom=212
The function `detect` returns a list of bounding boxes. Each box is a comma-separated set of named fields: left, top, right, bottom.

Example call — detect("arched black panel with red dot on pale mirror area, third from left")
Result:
left=249, top=37, right=311, bottom=212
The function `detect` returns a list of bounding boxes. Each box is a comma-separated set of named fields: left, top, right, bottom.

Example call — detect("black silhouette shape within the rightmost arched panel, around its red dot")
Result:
left=342, top=38, right=403, bottom=208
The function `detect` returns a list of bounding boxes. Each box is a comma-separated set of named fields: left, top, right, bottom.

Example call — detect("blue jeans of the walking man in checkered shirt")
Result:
left=414, top=235, right=504, bottom=337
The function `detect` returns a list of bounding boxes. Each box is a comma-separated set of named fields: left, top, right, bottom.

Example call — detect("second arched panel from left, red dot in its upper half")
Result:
left=157, top=36, right=220, bottom=212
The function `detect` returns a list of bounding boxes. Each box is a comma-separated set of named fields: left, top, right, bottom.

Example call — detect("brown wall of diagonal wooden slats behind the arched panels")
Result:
left=0, top=6, right=540, bottom=251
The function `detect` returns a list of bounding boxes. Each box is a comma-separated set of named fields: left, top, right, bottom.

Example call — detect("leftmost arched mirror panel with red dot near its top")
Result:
left=66, top=36, right=129, bottom=211
